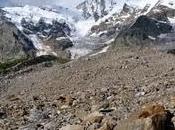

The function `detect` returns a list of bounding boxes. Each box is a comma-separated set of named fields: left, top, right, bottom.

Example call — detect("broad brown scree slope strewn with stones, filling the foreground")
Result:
left=0, top=48, right=175, bottom=130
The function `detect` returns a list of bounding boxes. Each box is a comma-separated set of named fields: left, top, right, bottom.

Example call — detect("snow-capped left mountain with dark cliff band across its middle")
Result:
left=3, top=6, right=82, bottom=56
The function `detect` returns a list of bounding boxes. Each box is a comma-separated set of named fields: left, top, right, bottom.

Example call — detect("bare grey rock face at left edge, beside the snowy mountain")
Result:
left=0, top=11, right=36, bottom=62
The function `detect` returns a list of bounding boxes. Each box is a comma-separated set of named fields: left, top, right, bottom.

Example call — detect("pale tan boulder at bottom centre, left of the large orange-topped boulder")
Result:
left=84, top=112, right=104, bottom=123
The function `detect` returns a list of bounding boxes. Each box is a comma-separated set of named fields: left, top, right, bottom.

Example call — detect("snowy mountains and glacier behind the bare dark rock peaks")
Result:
left=3, top=0, right=175, bottom=60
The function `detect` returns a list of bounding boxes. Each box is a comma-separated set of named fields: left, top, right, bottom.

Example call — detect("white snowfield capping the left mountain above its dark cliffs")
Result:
left=3, top=5, right=75, bottom=29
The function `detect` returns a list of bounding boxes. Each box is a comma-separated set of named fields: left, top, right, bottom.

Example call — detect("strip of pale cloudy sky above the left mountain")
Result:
left=0, top=0, right=83, bottom=8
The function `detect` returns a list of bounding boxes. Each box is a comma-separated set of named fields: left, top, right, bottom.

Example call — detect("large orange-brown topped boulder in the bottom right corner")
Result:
left=114, top=104, right=174, bottom=130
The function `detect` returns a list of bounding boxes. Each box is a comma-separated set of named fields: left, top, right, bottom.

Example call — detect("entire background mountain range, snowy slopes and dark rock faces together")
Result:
left=0, top=0, right=175, bottom=61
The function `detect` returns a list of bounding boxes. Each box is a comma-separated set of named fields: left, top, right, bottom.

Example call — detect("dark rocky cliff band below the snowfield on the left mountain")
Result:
left=21, top=18, right=73, bottom=54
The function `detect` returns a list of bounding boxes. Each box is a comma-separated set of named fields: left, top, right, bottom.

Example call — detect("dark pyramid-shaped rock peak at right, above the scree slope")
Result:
left=116, top=16, right=172, bottom=44
